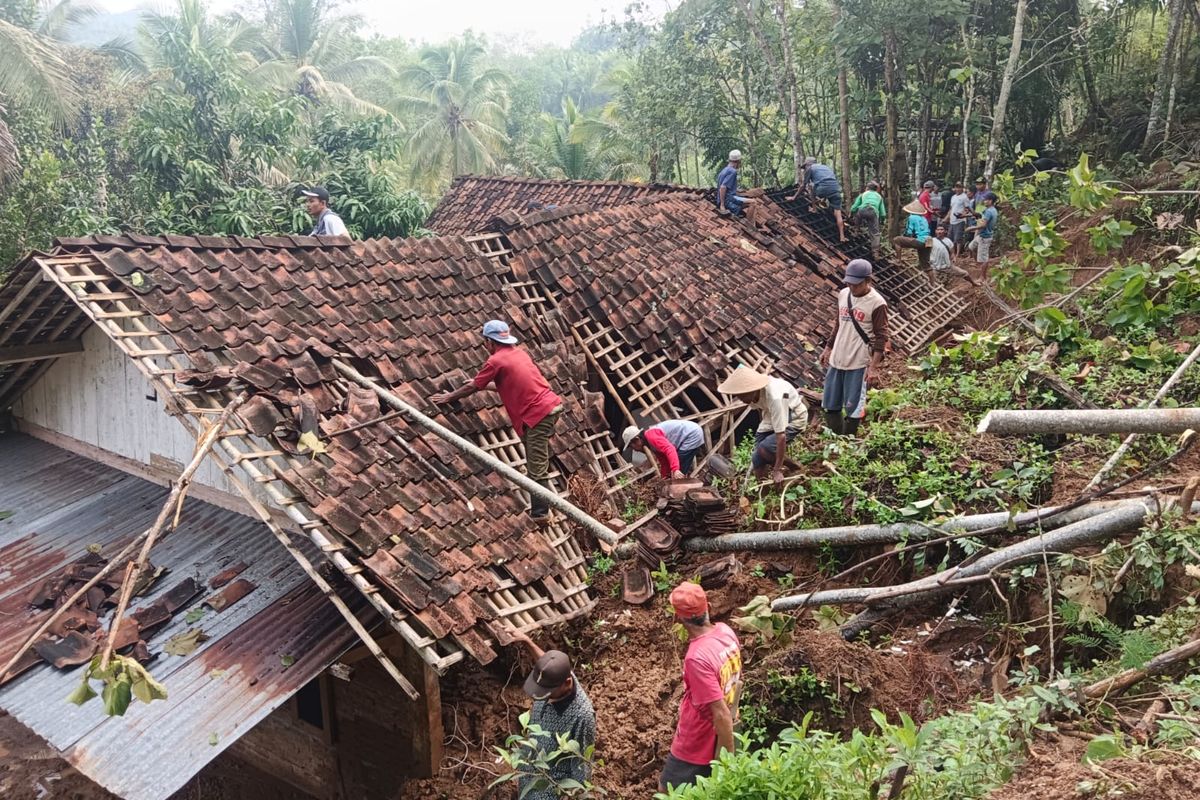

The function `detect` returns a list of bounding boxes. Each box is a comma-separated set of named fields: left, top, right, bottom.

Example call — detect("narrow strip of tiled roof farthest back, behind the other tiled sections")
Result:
left=425, top=175, right=703, bottom=236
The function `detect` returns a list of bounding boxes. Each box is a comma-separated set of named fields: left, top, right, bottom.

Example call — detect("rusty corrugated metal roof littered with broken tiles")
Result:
left=0, top=435, right=370, bottom=800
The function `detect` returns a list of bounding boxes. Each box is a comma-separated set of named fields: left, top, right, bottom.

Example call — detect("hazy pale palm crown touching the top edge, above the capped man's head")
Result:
left=253, top=0, right=396, bottom=114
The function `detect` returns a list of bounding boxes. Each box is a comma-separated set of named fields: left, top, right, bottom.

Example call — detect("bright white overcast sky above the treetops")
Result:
left=97, top=0, right=671, bottom=44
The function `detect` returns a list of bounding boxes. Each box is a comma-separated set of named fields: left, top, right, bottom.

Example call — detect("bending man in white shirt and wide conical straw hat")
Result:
left=716, top=366, right=809, bottom=486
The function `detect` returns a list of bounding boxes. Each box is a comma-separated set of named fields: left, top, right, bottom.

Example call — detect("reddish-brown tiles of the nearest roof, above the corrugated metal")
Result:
left=28, top=230, right=606, bottom=661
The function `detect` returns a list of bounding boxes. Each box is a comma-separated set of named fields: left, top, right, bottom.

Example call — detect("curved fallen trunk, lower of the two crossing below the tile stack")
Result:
left=770, top=500, right=1157, bottom=625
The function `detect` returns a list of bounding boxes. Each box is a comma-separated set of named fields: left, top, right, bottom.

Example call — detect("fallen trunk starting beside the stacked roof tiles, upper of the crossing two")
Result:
left=683, top=500, right=1128, bottom=553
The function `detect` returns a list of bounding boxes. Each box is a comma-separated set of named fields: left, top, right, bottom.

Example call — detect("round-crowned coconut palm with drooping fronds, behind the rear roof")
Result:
left=392, top=38, right=511, bottom=178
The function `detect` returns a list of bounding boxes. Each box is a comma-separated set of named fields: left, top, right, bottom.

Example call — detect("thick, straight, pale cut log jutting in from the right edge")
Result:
left=976, top=408, right=1200, bottom=437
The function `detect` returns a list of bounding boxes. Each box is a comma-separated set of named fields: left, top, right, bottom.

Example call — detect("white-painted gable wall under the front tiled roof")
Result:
left=13, top=325, right=266, bottom=500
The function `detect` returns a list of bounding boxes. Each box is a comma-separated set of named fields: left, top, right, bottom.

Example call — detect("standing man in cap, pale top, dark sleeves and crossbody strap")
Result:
left=821, top=258, right=888, bottom=435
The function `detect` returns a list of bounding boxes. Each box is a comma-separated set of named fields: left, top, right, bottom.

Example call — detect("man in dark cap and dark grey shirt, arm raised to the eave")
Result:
left=511, top=630, right=596, bottom=800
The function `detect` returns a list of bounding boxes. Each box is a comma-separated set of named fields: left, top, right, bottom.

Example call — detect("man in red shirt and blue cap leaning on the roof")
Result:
left=430, top=319, right=563, bottom=521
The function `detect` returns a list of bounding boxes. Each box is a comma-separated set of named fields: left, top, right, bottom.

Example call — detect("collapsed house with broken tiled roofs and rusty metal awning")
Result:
left=0, top=178, right=961, bottom=800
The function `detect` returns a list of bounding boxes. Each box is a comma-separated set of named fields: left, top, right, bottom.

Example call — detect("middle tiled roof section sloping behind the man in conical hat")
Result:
left=487, top=193, right=835, bottom=384
